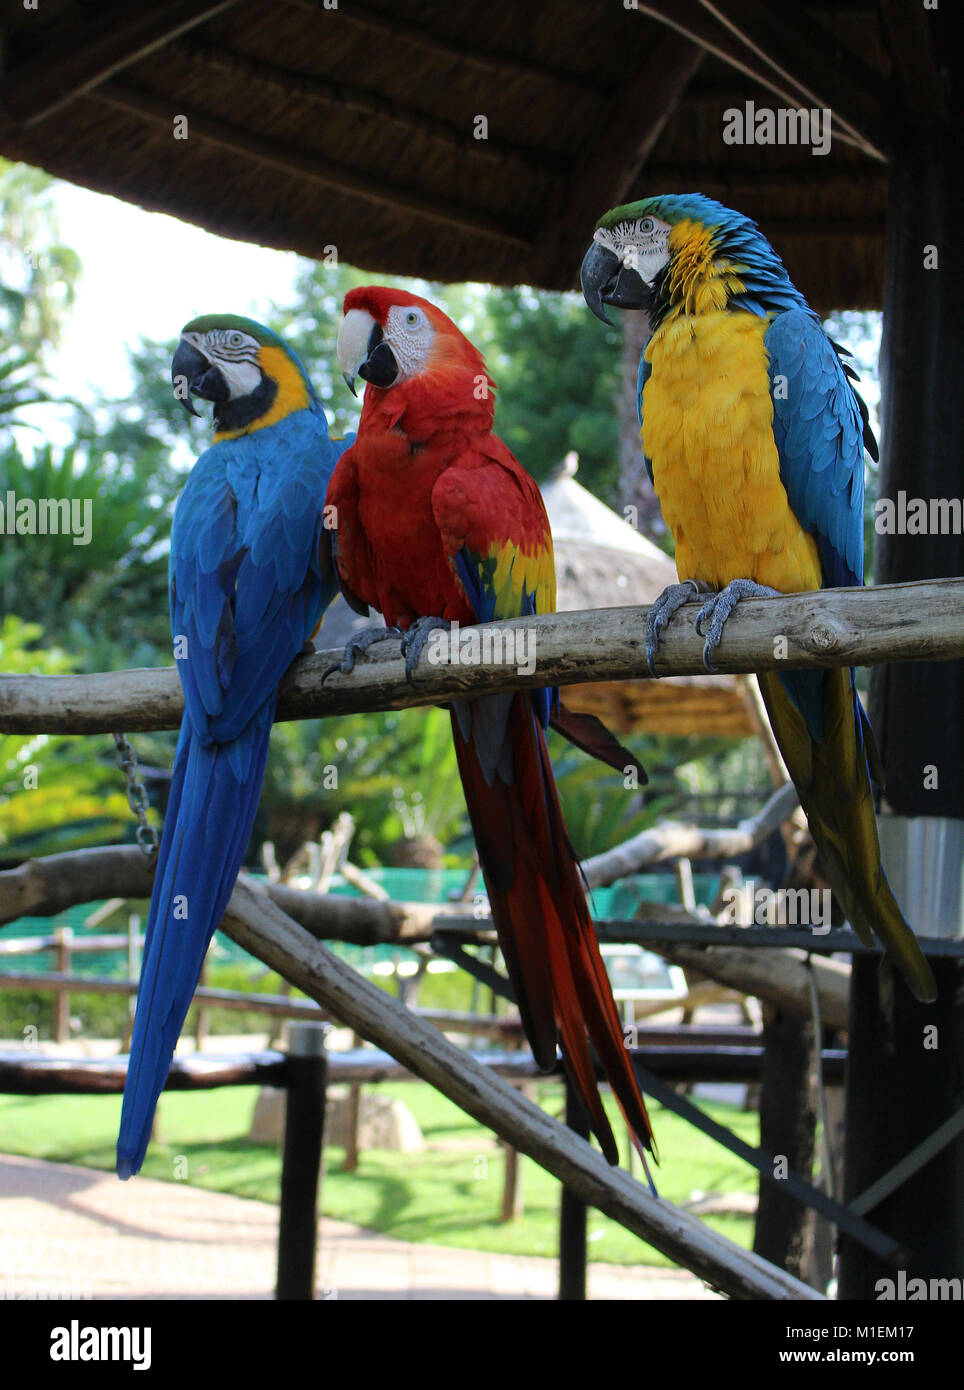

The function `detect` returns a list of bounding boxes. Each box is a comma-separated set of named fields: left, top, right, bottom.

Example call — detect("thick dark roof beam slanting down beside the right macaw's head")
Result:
left=535, top=33, right=703, bottom=284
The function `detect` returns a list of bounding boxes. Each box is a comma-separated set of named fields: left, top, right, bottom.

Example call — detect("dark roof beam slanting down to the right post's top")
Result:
left=638, top=0, right=888, bottom=160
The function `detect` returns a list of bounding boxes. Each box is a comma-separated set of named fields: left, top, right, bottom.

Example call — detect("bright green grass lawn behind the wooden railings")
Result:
left=0, top=1081, right=758, bottom=1265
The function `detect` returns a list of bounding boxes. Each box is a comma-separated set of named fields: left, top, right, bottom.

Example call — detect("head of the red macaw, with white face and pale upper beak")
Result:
left=338, top=285, right=492, bottom=392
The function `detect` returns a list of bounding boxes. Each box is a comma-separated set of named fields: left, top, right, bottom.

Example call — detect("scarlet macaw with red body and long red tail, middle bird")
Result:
left=328, top=288, right=653, bottom=1163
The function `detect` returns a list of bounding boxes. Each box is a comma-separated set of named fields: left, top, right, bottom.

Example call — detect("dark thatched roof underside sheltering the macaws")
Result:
left=0, top=0, right=943, bottom=307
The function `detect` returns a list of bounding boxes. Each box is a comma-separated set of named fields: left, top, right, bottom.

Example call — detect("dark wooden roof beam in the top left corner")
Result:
left=0, top=0, right=238, bottom=126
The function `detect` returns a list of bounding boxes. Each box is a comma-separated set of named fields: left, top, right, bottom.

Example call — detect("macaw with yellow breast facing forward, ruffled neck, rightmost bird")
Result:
left=582, top=193, right=935, bottom=999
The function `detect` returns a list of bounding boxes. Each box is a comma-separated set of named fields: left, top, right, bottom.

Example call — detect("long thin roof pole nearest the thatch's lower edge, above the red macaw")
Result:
left=90, top=81, right=531, bottom=250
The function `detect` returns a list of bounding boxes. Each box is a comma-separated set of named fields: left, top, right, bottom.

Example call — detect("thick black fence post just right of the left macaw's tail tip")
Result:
left=278, top=1023, right=328, bottom=1300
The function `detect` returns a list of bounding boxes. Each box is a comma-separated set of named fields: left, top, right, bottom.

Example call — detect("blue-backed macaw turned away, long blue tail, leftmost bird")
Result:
left=117, top=314, right=350, bottom=1177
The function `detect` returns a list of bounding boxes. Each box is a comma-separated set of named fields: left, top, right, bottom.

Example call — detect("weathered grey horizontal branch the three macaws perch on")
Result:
left=0, top=578, right=964, bottom=734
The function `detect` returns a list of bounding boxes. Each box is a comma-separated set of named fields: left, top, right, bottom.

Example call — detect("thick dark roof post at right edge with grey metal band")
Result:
left=839, top=105, right=964, bottom=1298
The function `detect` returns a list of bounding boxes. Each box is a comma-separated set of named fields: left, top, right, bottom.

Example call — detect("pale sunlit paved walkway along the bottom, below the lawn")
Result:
left=0, top=1155, right=715, bottom=1300
